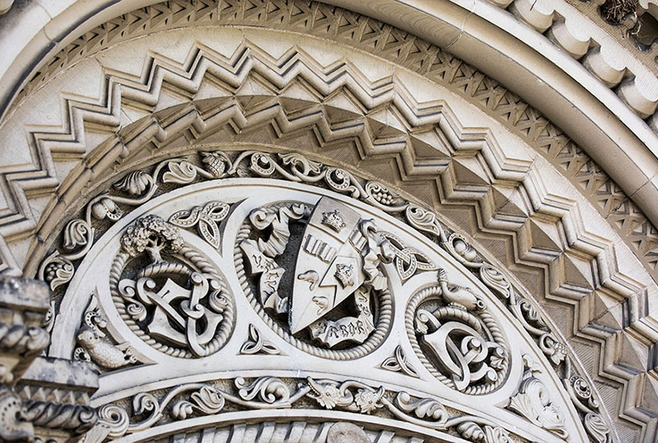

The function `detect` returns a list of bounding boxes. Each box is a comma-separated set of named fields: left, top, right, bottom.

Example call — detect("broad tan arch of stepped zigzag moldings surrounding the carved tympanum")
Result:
left=0, top=1, right=658, bottom=441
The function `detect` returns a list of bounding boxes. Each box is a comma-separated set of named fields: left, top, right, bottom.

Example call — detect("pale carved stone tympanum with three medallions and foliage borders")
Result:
left=33, top=151, right=608, bottom=443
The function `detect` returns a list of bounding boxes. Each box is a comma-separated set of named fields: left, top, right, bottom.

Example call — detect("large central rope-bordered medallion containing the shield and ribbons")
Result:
left=235, top=197, right=395, bottom=360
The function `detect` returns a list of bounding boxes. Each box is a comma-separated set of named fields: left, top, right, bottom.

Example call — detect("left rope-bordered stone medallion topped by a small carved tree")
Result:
left=111, top=215, right=235, bottom=357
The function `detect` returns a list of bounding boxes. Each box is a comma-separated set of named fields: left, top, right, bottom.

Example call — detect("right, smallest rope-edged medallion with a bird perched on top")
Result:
left=405, top=269, right=510, bottom=395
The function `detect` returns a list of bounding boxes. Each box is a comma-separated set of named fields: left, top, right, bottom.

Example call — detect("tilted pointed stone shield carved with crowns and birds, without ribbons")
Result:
left=288, top=197, right=366, bottom=334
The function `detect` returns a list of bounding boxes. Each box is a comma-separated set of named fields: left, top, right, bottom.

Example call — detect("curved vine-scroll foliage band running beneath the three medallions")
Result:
left=99, top=376, right=512, bottom=443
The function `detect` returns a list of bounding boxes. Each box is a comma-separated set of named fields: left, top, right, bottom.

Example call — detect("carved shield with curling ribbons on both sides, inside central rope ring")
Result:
left=240, top=197, right=395, bottom=348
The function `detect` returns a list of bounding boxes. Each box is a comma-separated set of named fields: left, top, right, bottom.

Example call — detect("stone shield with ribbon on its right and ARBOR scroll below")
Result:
left=288, top=197, right=393, bottom=346
